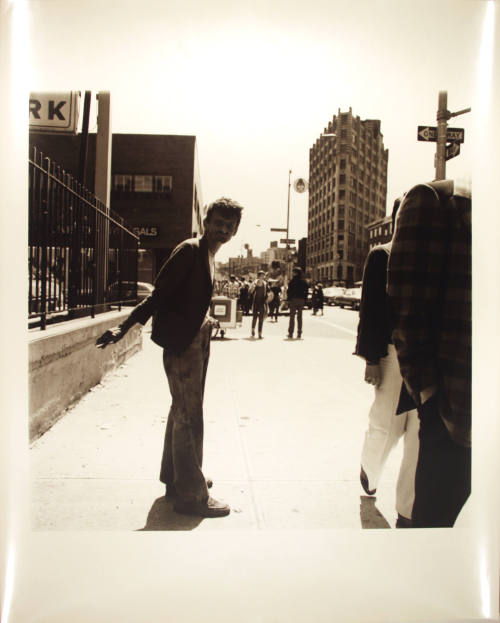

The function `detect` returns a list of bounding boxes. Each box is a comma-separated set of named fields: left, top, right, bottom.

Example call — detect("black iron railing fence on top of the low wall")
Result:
left=28, top=147, right=139, bottom=329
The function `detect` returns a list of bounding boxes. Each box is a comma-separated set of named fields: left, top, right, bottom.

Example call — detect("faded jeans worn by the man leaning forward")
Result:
left=160, top=324, right=212, bottom=502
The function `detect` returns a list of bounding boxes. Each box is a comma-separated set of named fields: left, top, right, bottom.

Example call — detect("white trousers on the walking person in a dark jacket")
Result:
left=361, top=344, right=419, bottom=519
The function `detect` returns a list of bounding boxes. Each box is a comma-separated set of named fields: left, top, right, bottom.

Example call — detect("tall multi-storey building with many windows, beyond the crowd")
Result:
left=306, top=109, right=389, bottom=287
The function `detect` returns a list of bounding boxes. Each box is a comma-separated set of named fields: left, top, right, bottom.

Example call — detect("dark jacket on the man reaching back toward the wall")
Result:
left=126, top=237, right=213, bottom=352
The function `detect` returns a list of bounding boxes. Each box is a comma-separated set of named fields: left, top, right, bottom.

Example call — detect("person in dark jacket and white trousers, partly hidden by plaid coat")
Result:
left=354, top=199, right=419, bottom=528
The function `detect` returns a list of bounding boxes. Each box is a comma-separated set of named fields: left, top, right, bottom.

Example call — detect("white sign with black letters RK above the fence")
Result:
left=29, top=91, right=80, bottom=134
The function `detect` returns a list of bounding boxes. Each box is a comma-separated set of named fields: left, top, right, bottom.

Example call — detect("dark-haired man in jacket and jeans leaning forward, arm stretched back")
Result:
left=97, top=197, right=243, bottom=517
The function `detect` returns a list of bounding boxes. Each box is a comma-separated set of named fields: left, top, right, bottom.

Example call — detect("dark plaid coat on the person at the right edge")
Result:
left=388, top=182, right=471, bottom=446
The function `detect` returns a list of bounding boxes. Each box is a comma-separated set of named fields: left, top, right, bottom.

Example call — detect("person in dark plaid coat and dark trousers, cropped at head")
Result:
left=388, top=180, right=472, bottom=528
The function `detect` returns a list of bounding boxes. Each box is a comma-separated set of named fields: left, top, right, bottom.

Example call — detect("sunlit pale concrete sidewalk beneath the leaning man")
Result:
left=31, top=310, right=410, bottom=531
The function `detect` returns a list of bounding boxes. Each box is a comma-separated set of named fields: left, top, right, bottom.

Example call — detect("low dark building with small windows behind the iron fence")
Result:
left=30, top=133, right=203, bottom=282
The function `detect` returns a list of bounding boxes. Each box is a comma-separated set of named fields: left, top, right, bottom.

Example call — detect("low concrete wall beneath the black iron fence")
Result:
left=29, top=309, right=142, bottom=441
